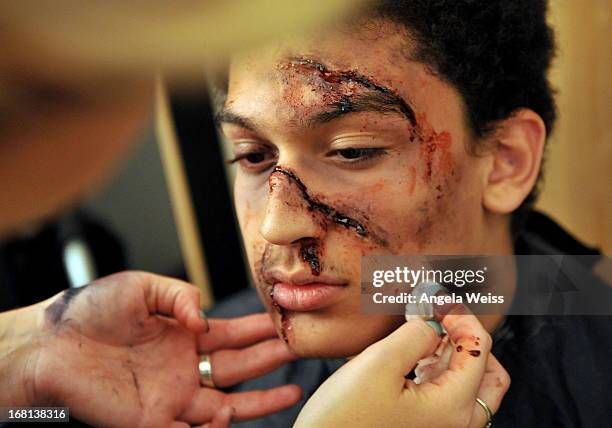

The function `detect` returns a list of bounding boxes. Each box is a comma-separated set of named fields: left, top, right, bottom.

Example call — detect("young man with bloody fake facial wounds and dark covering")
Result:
left=212, top=1, right=612, bottom=426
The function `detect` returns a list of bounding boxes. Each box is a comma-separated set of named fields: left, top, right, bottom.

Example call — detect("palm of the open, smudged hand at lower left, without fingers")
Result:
left=35, top=276, right=199, bottom=426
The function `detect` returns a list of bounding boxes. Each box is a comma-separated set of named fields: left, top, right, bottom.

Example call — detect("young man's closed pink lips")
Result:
left=270, top=274, right=346, bottom=312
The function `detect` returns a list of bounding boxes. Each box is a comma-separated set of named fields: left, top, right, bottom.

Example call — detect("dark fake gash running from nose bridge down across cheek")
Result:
left=270, top=166, right=387, bottom=246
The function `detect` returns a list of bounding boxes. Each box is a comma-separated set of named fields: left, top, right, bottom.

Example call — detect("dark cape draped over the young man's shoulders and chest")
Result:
left=211, top=213, right=612, bottom=427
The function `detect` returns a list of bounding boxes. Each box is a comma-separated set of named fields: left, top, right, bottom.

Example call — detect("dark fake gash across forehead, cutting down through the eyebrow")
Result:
left=281, top=57, right=417, bottom=126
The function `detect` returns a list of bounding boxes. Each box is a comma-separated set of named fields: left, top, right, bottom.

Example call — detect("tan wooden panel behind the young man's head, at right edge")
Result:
left=538, top=0, right=612, bottom=254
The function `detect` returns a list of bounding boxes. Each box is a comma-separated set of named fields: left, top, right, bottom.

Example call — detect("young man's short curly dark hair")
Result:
left=374, top=0, right=556, bottom=233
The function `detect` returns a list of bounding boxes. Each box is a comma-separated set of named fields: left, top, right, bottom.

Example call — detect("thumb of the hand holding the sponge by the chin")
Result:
left=364, top=319, right=440, bottom=383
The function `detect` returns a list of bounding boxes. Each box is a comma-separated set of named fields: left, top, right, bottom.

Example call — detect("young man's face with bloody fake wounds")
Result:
left=220, top=24, right=484, bottom=357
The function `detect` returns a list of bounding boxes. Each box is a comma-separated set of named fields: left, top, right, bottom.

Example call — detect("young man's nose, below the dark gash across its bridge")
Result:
left=260, top=172, right=323, bottom=245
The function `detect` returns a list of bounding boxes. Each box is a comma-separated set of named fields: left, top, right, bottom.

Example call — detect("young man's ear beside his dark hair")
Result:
left=482, top=109, right=546, bottom=214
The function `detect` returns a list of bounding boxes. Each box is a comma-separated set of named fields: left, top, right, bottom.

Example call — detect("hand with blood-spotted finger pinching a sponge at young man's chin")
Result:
left=294, top=305, right=510, bottom=428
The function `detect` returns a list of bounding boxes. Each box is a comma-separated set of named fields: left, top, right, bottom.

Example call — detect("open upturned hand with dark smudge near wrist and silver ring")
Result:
left=0, top=272, right=301, bottom=427
